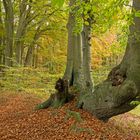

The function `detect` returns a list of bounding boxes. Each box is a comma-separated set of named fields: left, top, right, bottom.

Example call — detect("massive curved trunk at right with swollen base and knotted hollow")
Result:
left=79, top=0, right=140, bottom=120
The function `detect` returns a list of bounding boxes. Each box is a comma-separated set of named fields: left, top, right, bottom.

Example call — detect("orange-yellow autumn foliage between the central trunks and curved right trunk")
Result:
left=91, top=32, right=120, bottom=69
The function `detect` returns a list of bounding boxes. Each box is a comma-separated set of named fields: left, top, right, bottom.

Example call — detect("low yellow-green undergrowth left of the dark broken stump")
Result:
left=0, top=67, right=62, bottom=98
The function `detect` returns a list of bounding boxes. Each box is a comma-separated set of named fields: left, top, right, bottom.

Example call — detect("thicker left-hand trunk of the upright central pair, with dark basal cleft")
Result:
left=63, top=0, right=85, bottom=90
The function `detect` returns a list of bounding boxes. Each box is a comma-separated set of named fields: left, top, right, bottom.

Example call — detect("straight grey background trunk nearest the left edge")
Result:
left=3, top=0, right=14, bottom=66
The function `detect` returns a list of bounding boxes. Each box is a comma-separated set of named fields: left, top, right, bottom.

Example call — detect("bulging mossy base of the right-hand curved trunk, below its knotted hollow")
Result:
left=79, top=80, right=138, bottom=120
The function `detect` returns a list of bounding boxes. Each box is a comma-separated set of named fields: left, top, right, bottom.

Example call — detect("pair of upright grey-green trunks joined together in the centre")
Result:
left=64, top=0, right=93, bottom=92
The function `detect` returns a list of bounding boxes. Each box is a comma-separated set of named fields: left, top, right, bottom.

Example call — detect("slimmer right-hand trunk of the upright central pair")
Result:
left=82, top=0, right=94, bottom=93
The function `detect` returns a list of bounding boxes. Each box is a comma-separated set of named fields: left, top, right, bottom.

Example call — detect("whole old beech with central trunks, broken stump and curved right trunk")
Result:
left=37, top=0, right=140, bottom=120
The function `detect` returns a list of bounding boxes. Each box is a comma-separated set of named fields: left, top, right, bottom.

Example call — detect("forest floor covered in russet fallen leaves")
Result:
left=0, top=92, right=140, bottom=140
